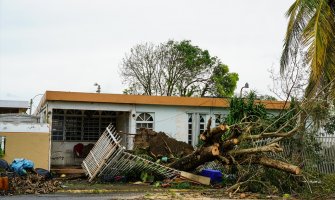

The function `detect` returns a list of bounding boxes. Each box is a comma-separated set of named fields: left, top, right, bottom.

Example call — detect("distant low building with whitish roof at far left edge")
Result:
left=0, top=100, right=29, bottom=114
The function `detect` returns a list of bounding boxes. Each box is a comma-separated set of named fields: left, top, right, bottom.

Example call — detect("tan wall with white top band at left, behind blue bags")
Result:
left=0, top=123, right=51, bottom=170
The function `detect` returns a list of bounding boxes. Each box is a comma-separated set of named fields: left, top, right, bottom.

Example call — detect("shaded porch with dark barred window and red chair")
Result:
left=50, top=109, right=131, bottom=166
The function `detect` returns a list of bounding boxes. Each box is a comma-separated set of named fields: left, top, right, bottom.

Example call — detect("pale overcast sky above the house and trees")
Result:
left=0, top=0, right=293, bottom=106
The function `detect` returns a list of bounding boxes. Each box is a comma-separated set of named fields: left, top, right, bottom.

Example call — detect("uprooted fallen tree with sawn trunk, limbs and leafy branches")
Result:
left=169, top=93, right=304, bottom=175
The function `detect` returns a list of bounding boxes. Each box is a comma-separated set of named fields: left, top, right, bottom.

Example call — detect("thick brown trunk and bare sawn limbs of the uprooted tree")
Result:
left=168, top=119, right=301, bottom=175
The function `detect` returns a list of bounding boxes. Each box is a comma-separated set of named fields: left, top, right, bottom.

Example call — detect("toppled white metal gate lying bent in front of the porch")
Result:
left=82, top=124, right=180, bottom=181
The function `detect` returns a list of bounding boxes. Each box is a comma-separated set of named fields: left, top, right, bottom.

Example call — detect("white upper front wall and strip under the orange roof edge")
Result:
left=46, top=101, right=228, bottom=146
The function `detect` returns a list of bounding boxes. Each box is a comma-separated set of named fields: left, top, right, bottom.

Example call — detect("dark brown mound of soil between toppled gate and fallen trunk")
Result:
left=134, top=129, right=194, bottom=158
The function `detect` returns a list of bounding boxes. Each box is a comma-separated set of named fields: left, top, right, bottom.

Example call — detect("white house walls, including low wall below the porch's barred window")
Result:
left=46, top=101, right=228, bottom=165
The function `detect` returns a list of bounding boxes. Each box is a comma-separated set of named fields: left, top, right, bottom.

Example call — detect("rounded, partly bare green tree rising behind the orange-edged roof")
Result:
left=120, top=40, right=238, bottom=97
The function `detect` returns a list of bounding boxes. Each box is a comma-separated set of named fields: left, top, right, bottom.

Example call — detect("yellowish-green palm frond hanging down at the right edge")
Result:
left=301, top=0, right=335, bottom=96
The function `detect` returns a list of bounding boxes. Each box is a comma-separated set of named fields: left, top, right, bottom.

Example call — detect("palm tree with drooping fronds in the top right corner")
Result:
left=280, top=0, right=335, bottom=98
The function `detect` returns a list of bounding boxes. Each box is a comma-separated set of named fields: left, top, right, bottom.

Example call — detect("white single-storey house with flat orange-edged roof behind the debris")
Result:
left=36, top=91, right=284, bottom=165
